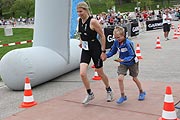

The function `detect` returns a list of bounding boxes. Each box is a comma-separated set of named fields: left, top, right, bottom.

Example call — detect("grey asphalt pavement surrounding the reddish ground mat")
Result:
left=0, top=21, right=180, bottom=119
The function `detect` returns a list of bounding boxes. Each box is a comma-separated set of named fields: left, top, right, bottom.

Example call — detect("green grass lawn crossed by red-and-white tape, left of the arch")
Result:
left=0, top=28, right=33, bottom=59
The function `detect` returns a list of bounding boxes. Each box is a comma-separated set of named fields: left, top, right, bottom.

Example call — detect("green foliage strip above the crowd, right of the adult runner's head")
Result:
left=85, top=0, right=180, bottom=13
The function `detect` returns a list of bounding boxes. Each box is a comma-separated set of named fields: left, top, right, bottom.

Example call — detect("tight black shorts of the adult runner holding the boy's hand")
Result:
left=80, top=40, right=103, bottom=68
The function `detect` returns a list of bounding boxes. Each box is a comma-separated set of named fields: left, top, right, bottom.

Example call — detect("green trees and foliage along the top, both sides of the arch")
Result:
left=0, top=0, right=180, bottom=18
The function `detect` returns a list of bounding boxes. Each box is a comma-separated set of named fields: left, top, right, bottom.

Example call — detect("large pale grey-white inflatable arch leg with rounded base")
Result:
left=0, top=0, right=81, bottom=90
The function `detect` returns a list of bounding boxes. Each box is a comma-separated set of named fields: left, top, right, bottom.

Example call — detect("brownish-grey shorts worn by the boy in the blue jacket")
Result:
left=117, top=62, right=139, bottom=77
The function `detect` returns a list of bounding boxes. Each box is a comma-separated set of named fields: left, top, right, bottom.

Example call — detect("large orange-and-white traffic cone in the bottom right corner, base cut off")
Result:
left=159, top=86, right=179, bottom=120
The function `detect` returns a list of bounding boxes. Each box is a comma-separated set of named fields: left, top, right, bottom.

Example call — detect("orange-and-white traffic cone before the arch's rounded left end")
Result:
left=19, top=77, right=37, bottom=108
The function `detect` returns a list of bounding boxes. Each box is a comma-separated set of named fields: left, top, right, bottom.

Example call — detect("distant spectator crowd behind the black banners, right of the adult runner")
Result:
left=95, top=7, right=180, bottom=28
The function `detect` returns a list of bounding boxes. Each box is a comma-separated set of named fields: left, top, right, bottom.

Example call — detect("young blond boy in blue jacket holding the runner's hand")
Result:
left=106, top=27, right=146, bottom=104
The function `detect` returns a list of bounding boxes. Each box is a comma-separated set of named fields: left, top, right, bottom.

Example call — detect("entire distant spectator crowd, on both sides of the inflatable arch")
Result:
left=0, top=7, right=180, bottom=28
